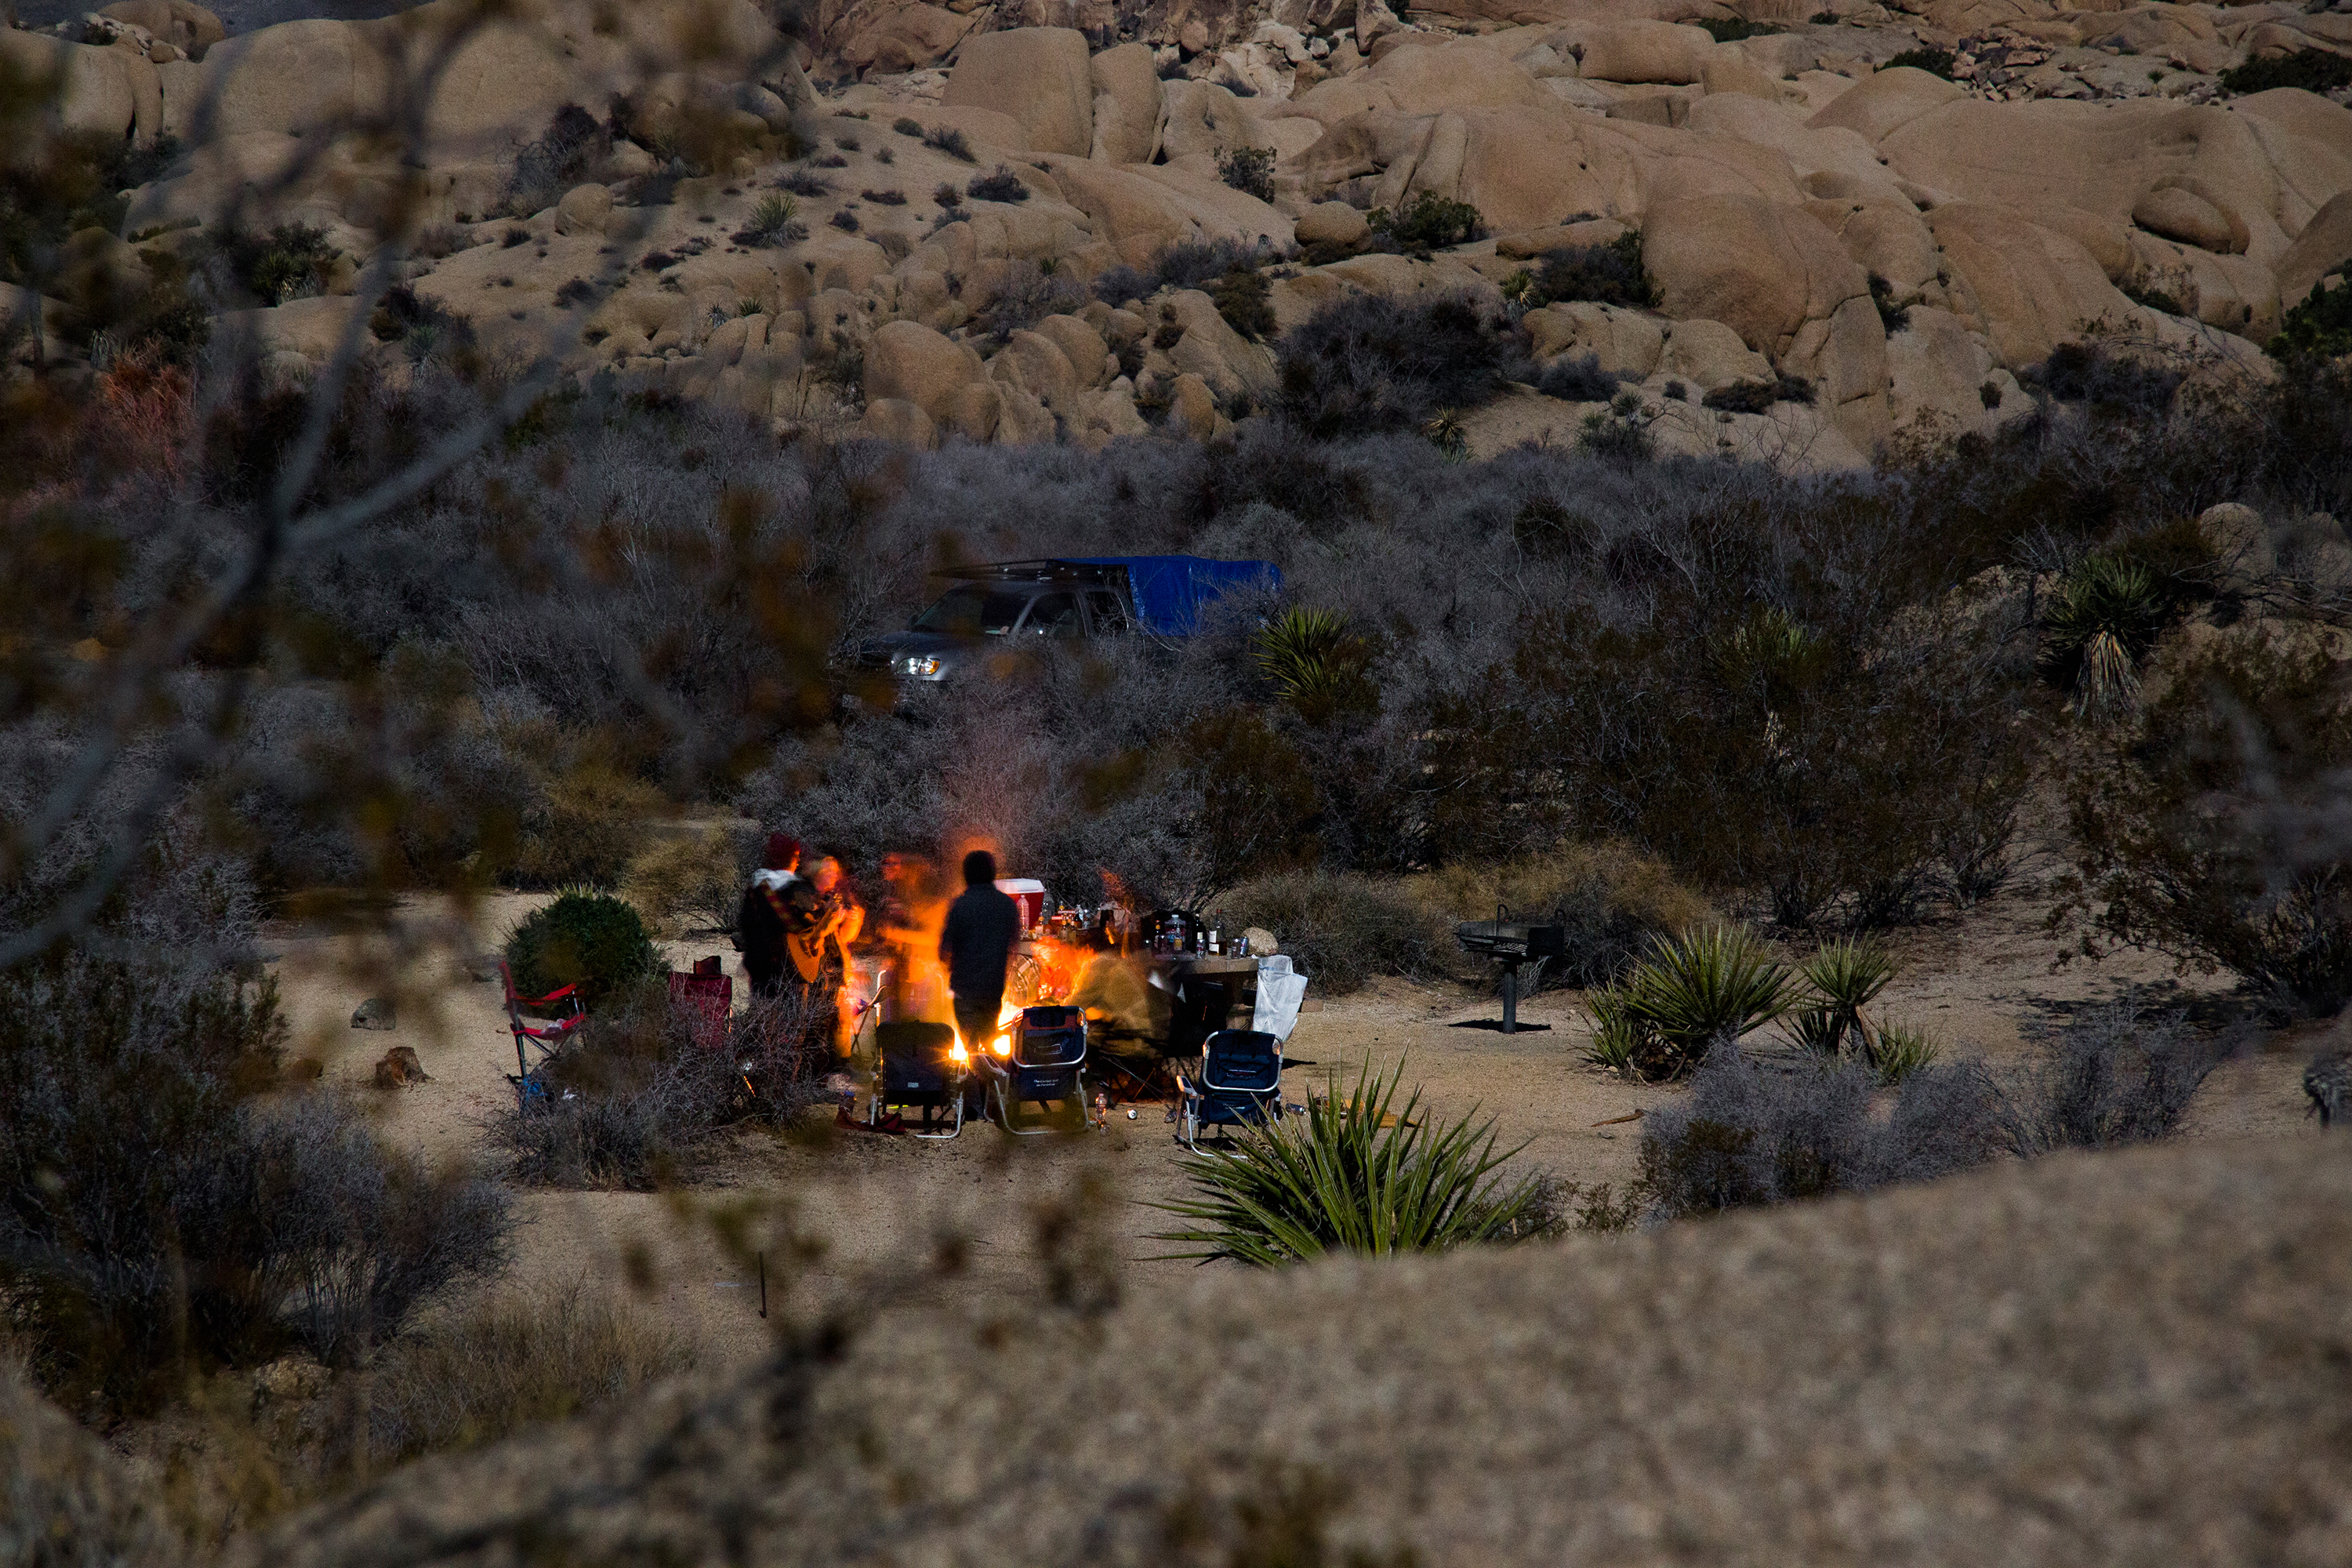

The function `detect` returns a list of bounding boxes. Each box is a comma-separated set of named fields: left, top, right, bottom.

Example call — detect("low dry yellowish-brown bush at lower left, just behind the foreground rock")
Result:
left=367, top=1283, right=694, bottom=1465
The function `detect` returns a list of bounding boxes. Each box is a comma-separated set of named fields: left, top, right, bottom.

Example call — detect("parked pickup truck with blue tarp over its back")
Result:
left=861, top=555, right=1282, bottom=682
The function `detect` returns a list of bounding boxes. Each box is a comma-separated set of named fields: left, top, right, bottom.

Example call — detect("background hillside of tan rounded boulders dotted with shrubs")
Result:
left=13, top=0, right=2352, bottom=466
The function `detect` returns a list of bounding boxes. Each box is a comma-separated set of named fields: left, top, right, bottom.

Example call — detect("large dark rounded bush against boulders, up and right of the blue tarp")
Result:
left=1275, top=294, right=1503, bottom=437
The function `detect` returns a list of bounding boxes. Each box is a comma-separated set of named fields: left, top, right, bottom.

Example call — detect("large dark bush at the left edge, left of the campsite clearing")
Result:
left=0, top=926, right=513, bottom=1410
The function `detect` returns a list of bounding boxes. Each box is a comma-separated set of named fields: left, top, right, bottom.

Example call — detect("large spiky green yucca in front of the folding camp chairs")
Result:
left=1155, top=1067, right=1552, bottom=1267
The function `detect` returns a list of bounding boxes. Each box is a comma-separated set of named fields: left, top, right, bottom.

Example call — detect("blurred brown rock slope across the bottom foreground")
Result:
left=0, top=1138, right=2258, bottom=1568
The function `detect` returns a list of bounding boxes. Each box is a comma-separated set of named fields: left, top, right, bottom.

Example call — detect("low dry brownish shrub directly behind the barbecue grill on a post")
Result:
left=1406, top=839, right=1715, bottom=987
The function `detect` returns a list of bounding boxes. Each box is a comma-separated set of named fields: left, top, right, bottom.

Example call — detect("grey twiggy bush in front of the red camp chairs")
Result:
left=489, top=982, right=833, bottom=1189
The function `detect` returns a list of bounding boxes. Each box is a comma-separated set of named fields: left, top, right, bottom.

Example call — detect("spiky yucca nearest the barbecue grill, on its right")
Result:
left=1588, top=926, right=1804, bottom=1081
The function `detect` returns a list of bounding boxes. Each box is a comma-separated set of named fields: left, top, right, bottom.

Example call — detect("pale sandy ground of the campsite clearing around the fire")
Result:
left=268, top=893, right=2338, bottom=1366
